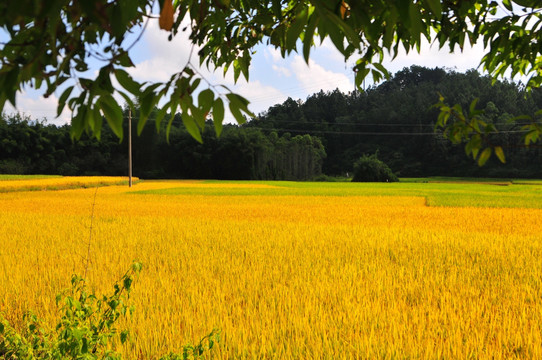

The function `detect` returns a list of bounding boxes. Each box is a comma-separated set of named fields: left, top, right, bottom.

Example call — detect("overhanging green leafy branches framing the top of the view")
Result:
left=0, top=0, right=542, bottom=163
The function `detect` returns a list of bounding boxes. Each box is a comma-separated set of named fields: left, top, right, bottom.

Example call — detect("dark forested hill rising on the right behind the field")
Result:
left=250, top=66, right=542, bottom=177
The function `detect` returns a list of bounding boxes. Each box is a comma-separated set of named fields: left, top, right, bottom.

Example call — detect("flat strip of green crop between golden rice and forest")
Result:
left=135, top=179, right=542, bottom=208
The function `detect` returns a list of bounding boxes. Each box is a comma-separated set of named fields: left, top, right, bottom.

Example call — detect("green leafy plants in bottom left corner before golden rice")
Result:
left=0, top=262, right=220, bottom=360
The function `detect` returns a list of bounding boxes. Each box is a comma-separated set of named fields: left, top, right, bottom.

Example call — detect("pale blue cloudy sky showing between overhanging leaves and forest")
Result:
left=5, top=20, right=483, bottom=124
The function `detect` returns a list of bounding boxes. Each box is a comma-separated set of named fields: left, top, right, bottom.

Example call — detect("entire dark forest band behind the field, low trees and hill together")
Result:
left=0, top=66, right=542, bottom=180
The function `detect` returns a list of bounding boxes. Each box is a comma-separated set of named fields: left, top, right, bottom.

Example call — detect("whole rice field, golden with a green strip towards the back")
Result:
left=0, top=179, right=542, bottom=359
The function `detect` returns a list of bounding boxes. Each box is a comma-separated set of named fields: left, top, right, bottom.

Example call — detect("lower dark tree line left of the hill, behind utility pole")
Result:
left=0, top=114, right=326, bottom=180
